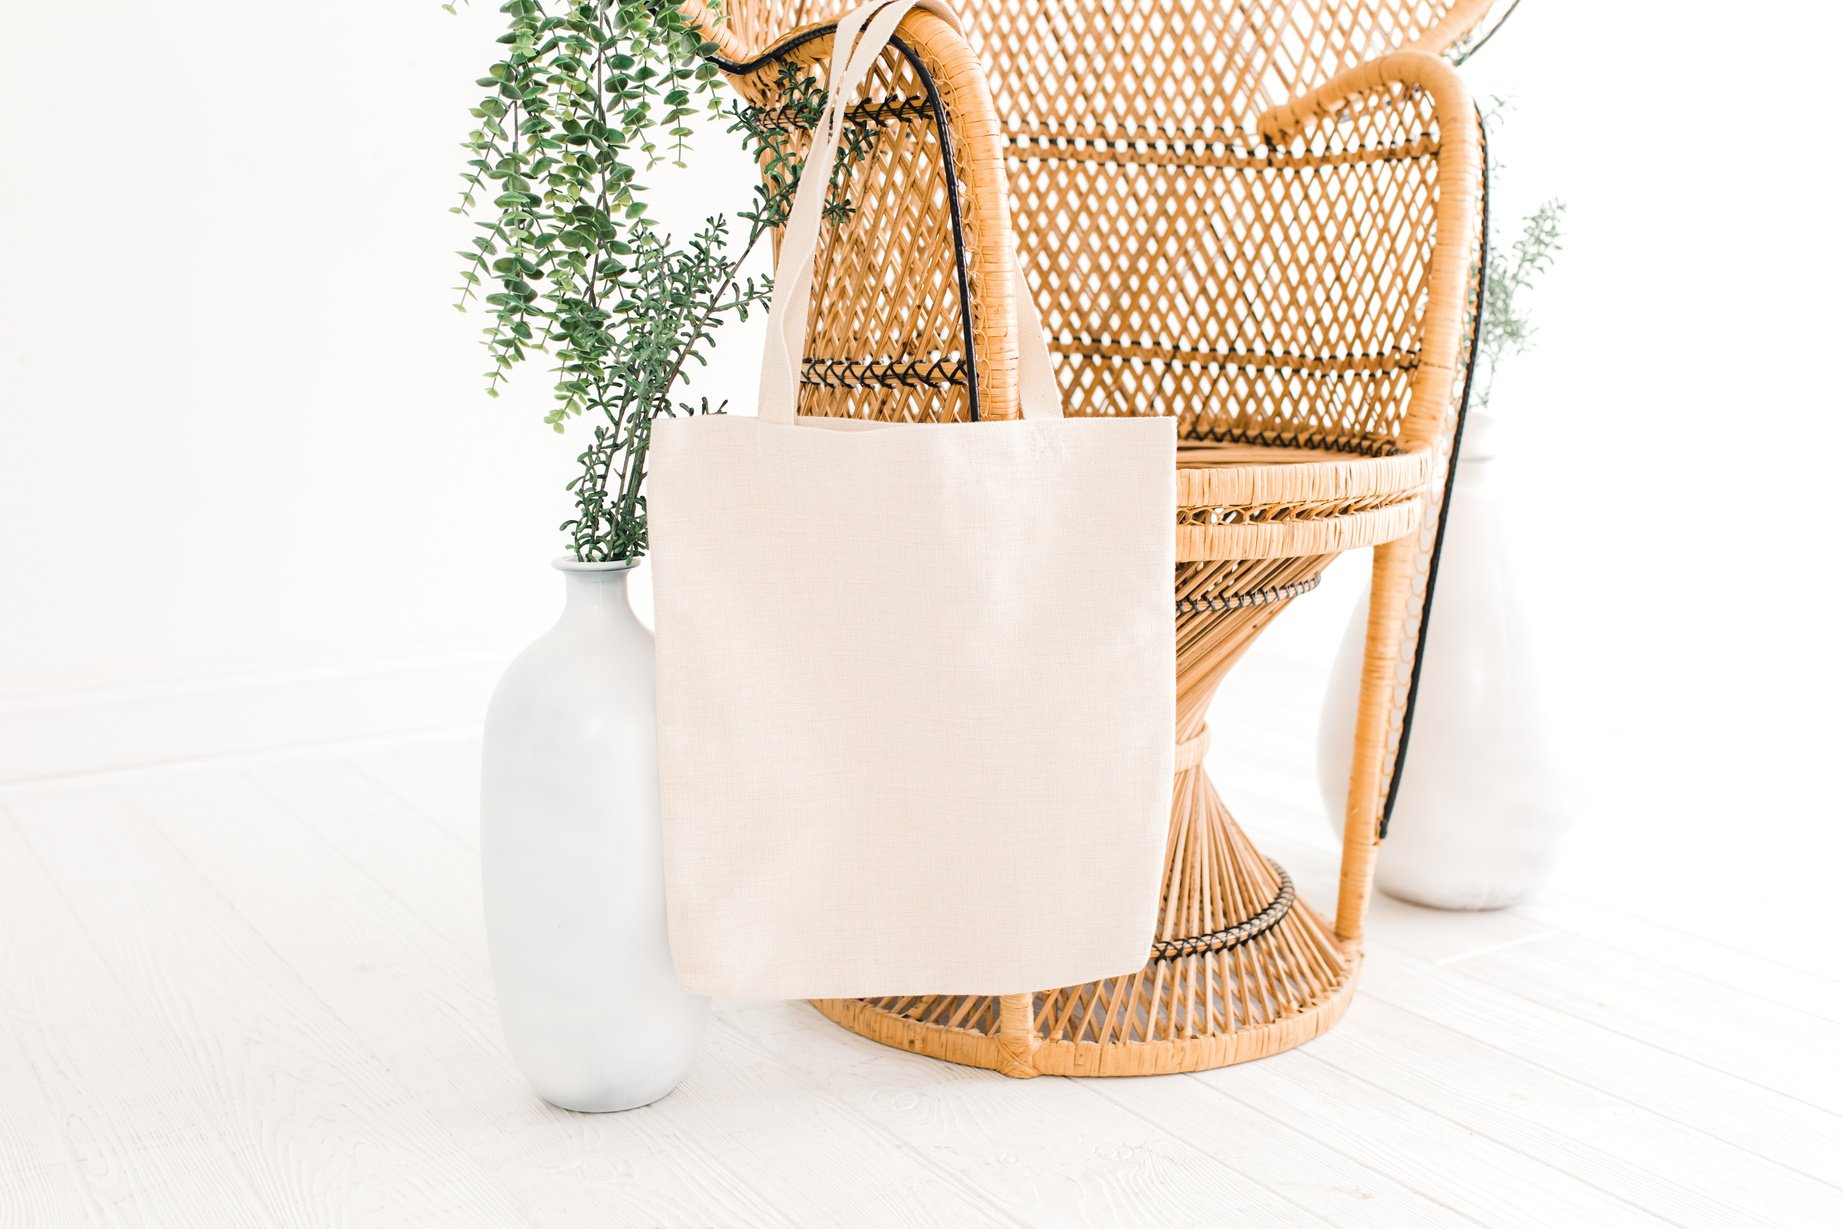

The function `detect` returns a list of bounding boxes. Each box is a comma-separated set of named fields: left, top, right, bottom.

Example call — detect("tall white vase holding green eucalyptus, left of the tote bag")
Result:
left=481, top=560, right=710, bottom=1111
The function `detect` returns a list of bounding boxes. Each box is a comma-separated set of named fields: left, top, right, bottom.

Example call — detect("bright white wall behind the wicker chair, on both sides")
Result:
left=0, top=0, right=1843, bottom=958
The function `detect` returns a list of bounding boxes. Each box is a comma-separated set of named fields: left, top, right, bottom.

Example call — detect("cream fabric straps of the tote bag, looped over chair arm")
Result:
left=756, top=0, right=1062, bottom=424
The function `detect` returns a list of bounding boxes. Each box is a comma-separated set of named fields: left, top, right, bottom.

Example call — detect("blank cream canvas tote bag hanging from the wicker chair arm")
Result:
left=649, top=0, right=1176, bottom=999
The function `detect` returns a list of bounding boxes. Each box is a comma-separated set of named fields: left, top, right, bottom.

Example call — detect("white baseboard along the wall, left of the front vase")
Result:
left=0, top=647, right=516, bottom=785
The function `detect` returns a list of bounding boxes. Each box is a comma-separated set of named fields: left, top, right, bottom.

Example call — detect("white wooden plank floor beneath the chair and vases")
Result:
left=0, top=735, right=1843, bottom=1229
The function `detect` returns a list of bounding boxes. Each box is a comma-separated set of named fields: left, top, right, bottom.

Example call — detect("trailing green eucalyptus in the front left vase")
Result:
left=455, top=0, right=874, bottom=562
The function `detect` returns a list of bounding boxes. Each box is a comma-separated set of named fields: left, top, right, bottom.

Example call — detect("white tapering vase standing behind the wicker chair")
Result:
left=1318, top=415, right=1570, bottom=908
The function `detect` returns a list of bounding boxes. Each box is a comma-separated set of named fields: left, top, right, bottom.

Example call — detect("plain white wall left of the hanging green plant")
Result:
left=0, top=0, right=763, bottom=778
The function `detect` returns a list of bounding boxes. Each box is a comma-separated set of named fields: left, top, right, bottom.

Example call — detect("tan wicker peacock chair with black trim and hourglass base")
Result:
left=687, top=0, right=1489, bottom=1076
